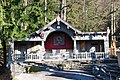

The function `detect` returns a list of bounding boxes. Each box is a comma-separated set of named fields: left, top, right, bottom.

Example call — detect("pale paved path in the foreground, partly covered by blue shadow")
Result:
left=15, top=71, right=96, bottom=80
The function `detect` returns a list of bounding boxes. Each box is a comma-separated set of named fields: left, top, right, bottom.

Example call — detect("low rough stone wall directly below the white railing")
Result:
left=18, top=61, right=88, bottom=69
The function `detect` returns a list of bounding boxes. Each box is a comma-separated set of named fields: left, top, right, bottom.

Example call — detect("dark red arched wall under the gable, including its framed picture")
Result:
left=45, top=31, right=73, bottom=50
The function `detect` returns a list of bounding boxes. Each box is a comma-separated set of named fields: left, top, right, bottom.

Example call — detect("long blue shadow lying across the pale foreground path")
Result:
left=46, top=71, right=96, bottom=80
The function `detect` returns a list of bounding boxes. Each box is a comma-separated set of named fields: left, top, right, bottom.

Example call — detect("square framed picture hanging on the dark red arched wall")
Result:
left=53, top=34, right=65, bottom=46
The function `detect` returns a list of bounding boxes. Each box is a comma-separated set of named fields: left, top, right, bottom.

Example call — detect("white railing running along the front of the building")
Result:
left=14, top=52, right=105, bottom=61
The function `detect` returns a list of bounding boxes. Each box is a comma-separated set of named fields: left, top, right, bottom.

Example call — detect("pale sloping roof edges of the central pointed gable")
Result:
left=36, top=16, right=81, bottom=34
